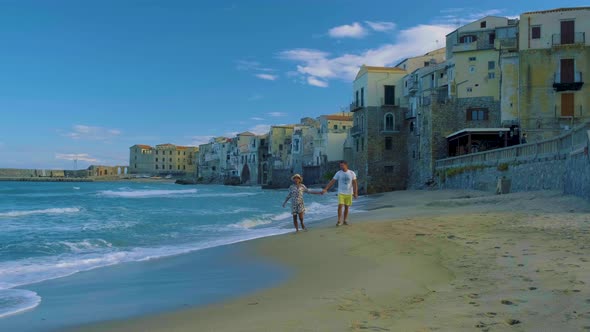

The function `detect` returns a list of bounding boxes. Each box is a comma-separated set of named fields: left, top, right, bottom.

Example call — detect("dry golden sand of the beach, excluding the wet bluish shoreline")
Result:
left=70, top=191, right=590, bottom=331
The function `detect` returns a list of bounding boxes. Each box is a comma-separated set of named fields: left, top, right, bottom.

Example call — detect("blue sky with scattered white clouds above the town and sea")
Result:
left=0, top=0, right=587, bottom=168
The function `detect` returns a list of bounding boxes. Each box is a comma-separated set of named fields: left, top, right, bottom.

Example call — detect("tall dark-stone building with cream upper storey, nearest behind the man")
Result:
left=350, top=66, right=407, bottom=194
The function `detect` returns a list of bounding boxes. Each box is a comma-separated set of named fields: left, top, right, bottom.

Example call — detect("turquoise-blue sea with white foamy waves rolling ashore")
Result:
left=0, top=182, right=346, bottom=323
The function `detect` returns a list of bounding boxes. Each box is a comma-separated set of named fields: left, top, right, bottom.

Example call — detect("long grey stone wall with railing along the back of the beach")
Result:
left=435, top=123, right=590, bottom=199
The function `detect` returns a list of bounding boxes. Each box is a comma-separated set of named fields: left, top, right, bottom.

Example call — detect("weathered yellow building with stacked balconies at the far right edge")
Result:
left=517, top=7, right=590, bottom=141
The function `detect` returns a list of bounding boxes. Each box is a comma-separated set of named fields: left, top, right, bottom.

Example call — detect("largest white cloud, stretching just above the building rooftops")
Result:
left=279, top=24, right=455, bottom=87
